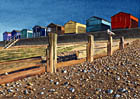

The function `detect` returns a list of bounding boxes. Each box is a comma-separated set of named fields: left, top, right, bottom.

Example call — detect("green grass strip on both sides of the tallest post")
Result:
left=0, top=46, right=82, bottom=62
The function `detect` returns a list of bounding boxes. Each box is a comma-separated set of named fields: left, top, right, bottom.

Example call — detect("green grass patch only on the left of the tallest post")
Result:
left=0, top=48, right=45, bottom=62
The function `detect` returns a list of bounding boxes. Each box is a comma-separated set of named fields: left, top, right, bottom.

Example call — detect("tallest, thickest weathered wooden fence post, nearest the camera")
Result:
left=46, top=33, right=57, bottom=73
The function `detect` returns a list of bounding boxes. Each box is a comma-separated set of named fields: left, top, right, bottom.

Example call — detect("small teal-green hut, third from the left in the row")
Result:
left=21, top=29, right=33, bottom=39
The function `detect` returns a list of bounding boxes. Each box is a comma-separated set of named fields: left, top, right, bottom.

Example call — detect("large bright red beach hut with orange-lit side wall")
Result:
left=111, top=12, right=138, bottom=29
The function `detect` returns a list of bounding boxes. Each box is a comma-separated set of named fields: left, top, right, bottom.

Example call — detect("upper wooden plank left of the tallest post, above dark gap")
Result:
left=0, top=57, right=42, bottom=75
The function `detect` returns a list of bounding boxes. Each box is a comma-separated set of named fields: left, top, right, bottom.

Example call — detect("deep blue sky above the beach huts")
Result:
left=0, top=0, right=140, bottom=41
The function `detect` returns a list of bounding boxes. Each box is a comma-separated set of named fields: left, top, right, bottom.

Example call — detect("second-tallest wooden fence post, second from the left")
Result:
left=86, top=35, right=94, bottom=62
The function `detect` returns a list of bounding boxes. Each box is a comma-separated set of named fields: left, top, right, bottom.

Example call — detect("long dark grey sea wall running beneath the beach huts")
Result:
left=0, top=28, right=140, bottom=46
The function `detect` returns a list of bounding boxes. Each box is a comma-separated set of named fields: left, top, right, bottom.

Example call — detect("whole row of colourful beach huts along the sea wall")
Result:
left=3, top=12, right=138, bottom=41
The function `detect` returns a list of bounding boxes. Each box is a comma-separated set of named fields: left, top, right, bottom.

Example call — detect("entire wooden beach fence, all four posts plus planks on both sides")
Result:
left=0, top=33, right=124, bottom=84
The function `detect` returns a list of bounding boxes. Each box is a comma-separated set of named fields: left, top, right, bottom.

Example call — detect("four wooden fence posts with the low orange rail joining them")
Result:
left=46, top=33, right=124, bottom=73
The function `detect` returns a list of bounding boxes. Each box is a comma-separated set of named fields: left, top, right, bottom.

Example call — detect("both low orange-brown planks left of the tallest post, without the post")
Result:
left=0, top=57, right=45, bottom=84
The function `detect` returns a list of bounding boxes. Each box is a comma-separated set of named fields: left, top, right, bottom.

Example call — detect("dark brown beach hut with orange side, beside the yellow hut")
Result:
left=47, top=23, right=64, bottom=35
